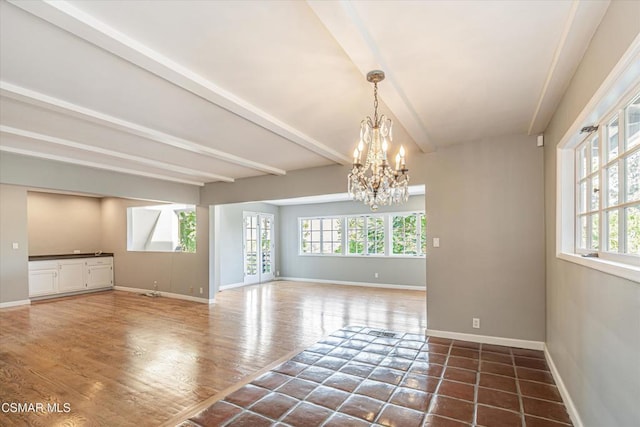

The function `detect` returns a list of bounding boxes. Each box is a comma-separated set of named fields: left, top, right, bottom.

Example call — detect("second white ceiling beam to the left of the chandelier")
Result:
left=0, top=81, right=286, bottom=175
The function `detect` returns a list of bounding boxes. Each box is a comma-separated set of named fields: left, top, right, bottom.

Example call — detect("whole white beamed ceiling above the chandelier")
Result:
left=0, top=0, right=609, bottom=185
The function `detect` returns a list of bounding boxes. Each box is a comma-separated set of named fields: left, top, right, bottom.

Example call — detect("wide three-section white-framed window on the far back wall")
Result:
left=299, top=212, right=427, bottom=256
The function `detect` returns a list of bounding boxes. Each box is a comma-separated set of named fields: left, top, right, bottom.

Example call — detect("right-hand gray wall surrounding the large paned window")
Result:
left=544, top=1, right=640, bottom=427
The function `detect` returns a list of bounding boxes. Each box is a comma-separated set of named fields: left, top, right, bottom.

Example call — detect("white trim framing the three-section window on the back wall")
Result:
left=297, top=210, right=426, bottom=259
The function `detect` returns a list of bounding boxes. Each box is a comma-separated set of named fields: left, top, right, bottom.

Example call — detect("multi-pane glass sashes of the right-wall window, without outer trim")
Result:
left=575, top=94, right=640, bottom=261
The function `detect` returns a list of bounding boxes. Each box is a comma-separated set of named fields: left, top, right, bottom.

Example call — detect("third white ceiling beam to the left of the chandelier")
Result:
left=0, top=124, right=234, bottom=182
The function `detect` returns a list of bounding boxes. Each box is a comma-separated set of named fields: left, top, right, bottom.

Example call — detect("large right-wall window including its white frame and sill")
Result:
left=556, top=75, right=640, bottom=281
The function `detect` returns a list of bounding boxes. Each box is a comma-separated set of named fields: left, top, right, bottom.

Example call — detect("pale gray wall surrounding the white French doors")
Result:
left=214, top=203, right=281, bottom=286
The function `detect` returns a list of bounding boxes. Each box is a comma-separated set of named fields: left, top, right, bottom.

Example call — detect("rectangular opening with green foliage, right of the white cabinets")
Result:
left=127, top=204, right=196, bottom=253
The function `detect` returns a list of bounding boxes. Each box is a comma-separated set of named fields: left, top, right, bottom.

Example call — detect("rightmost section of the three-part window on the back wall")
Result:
left=391, top=213, right=427, bottom=255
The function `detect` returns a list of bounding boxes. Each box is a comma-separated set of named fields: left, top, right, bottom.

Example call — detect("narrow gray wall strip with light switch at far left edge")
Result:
left=0, top=184, right=29, bottom=303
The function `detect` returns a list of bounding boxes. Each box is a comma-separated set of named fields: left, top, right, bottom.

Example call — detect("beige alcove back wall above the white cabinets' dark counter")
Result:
left=27, top=191, right=104, bottom=255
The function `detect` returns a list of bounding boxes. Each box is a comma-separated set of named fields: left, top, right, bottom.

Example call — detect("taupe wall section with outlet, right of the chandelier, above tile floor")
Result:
left=424, top=135, right=545, bottom=341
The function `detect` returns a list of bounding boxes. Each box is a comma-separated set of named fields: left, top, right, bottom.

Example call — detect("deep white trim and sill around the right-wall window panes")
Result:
left=556, top=36, right=640, bottom=282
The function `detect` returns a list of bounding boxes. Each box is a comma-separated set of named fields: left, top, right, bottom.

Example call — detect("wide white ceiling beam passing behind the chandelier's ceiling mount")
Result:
left=307, top=0, right=436, bottom=153
